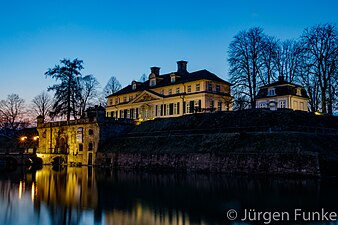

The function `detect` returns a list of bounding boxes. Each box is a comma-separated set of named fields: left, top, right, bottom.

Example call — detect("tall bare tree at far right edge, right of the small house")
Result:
left=301, top=24, right=338, bottom=114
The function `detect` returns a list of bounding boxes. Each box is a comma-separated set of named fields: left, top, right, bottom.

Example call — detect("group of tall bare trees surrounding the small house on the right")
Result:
left=228, top=24, right=338, bottom=114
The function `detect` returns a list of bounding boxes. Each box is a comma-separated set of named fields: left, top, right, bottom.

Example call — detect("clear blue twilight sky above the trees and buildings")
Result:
left=0, top=0, right=338, bottom=103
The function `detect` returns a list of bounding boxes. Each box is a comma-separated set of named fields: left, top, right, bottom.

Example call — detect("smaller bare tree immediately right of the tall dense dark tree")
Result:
left=80, top=75, right=100, bottom=115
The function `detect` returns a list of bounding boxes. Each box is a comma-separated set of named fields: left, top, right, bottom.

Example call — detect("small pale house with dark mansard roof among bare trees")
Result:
left=256, top=76, right=309, bottom=111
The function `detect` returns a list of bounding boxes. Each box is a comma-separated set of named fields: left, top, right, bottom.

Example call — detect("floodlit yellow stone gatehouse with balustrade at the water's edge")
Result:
left=37, top=106, right=130, bottom=165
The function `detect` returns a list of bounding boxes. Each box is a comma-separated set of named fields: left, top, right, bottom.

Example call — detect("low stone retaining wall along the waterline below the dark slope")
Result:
left=96, top=152, right=320, bottom=176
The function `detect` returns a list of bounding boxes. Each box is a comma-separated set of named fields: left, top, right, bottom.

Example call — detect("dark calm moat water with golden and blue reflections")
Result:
left=0, top=166, right=338, bottom=225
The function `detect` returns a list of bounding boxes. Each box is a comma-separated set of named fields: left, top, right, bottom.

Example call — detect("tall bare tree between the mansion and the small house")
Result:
left=228, top=27, right=267, bottom=108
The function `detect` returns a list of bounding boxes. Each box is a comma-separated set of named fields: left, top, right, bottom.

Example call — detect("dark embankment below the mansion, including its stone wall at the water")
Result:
left=96, top=110, right=338, bottom=176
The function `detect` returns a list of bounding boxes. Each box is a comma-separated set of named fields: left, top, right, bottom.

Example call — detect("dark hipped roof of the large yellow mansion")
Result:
left=107, top=70, right=230, bottom=98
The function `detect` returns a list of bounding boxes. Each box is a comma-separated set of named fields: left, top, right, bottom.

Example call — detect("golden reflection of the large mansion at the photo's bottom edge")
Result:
left=105, top=203, right=197, bottom=225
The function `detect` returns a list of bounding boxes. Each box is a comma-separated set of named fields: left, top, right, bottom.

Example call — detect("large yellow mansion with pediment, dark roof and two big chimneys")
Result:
left=106, top=61, right=232, bottom=120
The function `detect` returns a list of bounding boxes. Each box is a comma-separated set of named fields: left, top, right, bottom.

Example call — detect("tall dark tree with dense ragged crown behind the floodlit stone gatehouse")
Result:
left=45, top=59, right=83, bottom=120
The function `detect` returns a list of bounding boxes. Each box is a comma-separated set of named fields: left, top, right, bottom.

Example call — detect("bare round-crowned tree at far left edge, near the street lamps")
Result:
left=0, top=94, right=27, bottom=134
